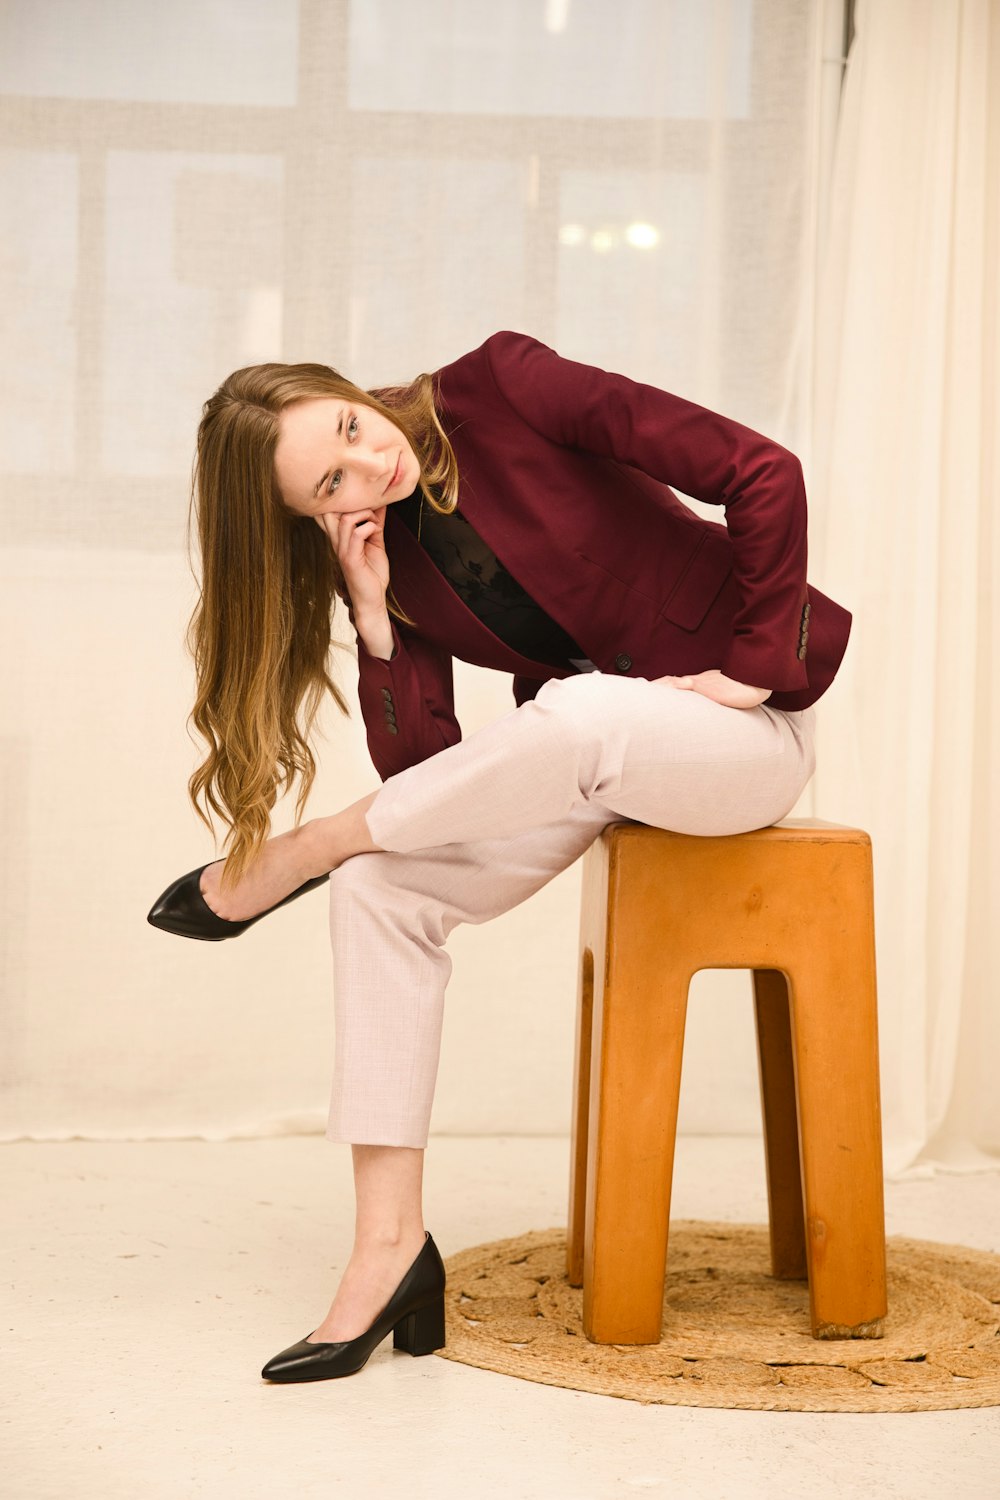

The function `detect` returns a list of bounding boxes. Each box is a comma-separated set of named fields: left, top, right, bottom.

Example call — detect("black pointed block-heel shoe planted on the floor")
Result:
left=261, top=1230, right=445, bottom=1385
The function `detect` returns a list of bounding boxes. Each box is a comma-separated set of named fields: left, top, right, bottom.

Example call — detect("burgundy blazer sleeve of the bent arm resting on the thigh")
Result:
left=484, top=332, right=808, bottom=692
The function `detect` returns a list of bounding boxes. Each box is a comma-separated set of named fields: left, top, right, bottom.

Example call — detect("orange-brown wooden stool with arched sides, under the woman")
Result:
left=567, top=818, right=886, bottom=1344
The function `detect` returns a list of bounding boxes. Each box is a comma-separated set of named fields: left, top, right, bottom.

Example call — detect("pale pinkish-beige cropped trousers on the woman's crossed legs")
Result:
left=327, top=672, right=816, bottom=1148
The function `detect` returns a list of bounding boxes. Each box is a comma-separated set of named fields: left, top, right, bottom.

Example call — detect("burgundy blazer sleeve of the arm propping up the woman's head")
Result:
left=348, top=605, right=462, bottom=782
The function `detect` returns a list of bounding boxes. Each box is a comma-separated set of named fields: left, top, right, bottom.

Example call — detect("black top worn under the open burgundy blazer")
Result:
left=397, top=491, right=595, bottom=672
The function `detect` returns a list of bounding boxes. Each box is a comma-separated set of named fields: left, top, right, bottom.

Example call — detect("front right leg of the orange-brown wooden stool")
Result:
left=790, top=920, right=886, bottom=1338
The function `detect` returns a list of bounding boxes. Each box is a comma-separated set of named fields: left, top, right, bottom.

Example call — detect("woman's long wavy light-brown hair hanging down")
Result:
left=184, top=365, right=459, bottom=890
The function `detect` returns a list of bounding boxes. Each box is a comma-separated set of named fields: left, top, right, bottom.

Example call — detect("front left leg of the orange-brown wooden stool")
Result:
left=583, top=948, right=690, bottom=1344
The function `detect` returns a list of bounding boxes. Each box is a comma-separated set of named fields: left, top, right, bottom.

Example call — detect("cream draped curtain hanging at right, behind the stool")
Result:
left=811, top=0, right=1000, bottom=1173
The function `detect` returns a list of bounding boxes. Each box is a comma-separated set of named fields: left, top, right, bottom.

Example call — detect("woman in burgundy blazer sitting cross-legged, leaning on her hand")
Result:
left=150, top=332, right=850, bottom=1380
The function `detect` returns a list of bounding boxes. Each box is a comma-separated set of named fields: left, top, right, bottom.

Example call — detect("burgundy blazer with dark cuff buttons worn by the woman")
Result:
left=349, top=332, right=852, bottom=780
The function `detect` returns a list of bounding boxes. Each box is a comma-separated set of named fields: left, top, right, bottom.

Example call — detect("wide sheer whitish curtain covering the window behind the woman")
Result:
left=0, top=0, right=851, bottom=1137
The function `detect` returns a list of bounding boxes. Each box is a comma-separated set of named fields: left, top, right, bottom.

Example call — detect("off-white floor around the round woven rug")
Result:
left=0, top=1137, right=1000, bottom=1500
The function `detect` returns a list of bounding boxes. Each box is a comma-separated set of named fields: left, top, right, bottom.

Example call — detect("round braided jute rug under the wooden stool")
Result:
left=438, top=1220, right=1000, bottom=1412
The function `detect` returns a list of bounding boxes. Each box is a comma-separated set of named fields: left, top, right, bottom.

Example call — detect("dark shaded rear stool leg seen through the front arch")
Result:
left=753, top=969, right=808, bottom=1281
